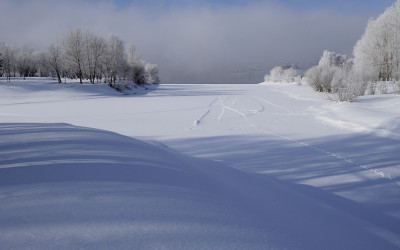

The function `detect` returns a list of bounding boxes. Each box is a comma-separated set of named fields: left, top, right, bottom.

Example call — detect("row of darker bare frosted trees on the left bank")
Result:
left=0, top=29, right=160, bottom=87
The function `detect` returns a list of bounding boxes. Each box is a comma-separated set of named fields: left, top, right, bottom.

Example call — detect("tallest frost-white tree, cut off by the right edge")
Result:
left=353, top=0, right=400, bottom=81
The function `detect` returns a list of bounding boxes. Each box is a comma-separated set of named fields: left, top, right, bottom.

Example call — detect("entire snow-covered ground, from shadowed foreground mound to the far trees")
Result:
left=0, top=79, right=400, bottom=249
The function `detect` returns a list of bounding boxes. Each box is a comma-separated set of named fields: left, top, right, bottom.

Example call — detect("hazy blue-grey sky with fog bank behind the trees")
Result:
left=0, top=0, right=395, bottom=83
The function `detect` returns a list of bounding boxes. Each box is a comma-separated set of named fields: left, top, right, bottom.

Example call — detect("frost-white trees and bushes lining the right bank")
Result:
left=265, top=0, right=400, bottom=101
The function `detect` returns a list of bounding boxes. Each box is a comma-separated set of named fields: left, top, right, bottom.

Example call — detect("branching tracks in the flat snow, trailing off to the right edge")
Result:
left=192, top=96, right=400, bottom=187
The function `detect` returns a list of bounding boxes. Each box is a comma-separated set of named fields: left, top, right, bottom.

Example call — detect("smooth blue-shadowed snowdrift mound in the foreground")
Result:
left=0, top=123, right=396, bottom=249
